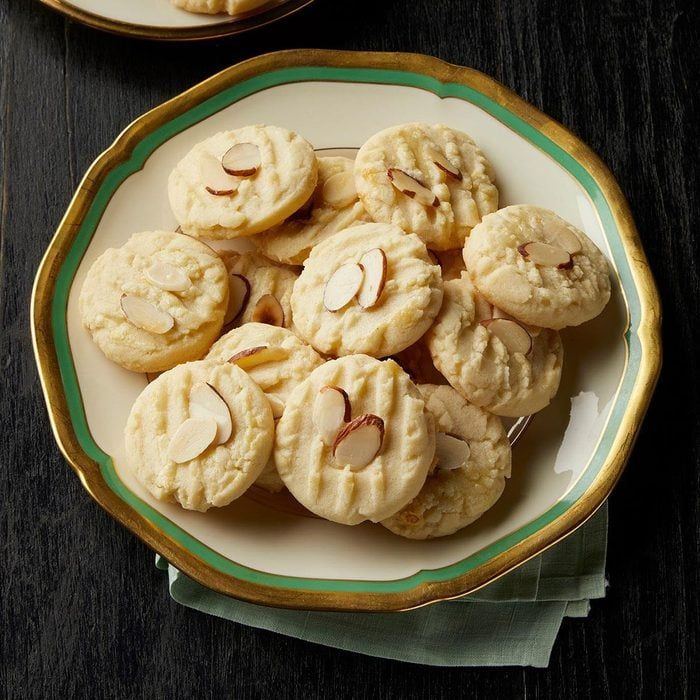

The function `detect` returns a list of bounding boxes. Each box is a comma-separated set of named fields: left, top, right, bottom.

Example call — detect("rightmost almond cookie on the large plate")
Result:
left=464, top=204, right=610, bottom=329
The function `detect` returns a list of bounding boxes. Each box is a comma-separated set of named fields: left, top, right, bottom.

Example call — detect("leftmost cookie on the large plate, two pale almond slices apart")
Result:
left=80, top=231, right=228, bottom=372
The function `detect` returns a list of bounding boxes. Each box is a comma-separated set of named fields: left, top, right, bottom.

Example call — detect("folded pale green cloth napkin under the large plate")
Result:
left=156, top=503, right=608, bottom=667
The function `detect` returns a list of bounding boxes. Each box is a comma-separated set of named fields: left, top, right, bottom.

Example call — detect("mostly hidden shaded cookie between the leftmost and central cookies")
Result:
left=221, top=253, right=299, bottom=328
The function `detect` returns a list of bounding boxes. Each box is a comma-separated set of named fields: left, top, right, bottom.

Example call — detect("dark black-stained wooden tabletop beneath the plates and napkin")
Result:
left=0, top=0, right=700, bottom=698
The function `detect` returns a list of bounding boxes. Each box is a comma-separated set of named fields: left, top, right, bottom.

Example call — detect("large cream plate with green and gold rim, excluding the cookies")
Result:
left=34, top=52, right=659, bottom=610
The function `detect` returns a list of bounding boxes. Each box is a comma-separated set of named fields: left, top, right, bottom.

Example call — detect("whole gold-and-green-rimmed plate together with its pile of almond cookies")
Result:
left=32, top=51, right=661, bottom=611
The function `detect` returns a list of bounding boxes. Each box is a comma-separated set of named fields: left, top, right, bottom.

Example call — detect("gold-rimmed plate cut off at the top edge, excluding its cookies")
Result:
left=39, top=0, right=313, bottom=41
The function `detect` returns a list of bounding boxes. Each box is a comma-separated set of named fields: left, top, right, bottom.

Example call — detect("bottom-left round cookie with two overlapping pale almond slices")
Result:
left=125, top=362, right=274, bottom=511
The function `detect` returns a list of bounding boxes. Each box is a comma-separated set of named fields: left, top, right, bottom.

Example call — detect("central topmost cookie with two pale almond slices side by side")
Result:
left=292, top=224, right=442, bottom=357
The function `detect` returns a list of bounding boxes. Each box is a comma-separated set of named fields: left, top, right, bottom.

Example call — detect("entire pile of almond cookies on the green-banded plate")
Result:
left=80, top=123, right=610, bottom=539
